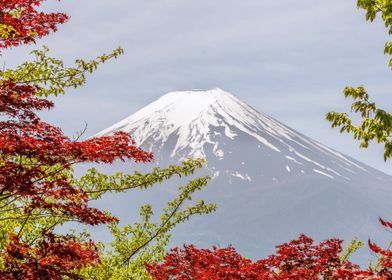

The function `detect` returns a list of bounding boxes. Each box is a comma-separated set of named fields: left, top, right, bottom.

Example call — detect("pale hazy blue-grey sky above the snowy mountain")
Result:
left=0, top=0, right=392, bottom=174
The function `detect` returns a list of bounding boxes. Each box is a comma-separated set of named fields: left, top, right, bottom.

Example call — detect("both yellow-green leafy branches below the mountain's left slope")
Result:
left=81, top=160, right=216, bottom=280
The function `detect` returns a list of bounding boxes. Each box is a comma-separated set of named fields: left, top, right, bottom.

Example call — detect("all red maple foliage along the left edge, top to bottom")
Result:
left=0, top=0, right=152, bottom=279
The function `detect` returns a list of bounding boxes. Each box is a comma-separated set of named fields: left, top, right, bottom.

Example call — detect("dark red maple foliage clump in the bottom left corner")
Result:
left=1, top=233, right=99, bottom=280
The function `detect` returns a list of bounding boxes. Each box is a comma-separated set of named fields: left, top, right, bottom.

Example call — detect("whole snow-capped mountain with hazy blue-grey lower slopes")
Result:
left=95, top=88, right=392, bottom=262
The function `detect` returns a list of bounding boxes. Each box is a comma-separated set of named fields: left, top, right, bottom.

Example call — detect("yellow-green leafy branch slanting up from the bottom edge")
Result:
left=81, top=165, right=217, bottom=280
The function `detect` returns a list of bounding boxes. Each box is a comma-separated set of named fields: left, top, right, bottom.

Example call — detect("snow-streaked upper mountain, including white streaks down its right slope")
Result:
left=98, top=88, right=366, bottom=182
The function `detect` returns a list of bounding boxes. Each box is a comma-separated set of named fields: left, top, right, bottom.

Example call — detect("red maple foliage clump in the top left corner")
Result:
left=0, top=0, right=68, bottom=48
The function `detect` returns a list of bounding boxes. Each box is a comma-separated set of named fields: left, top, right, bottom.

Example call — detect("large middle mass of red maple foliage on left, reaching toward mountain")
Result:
left=0, top=81, right=152, bottom=225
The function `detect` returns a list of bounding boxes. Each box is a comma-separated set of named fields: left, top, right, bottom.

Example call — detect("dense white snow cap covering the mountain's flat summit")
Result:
left=101, top=88, right=279, bottom=157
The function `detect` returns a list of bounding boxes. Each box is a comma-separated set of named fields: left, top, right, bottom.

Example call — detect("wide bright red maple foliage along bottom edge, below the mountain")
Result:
left=146, top=235, right=390, bottom=280
